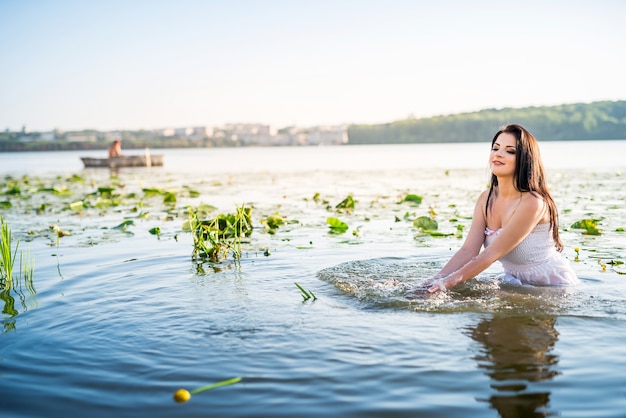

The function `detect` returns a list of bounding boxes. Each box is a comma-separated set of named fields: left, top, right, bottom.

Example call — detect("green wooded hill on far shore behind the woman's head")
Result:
left=348, top=101, right=626, bottom=144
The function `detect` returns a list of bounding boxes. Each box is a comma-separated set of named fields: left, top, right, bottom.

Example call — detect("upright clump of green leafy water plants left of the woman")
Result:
left=188, top=205, right=252, bottom=262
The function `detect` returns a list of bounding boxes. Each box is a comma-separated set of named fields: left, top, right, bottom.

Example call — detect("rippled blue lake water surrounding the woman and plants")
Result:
left=0, top=141, right=626, bottom=418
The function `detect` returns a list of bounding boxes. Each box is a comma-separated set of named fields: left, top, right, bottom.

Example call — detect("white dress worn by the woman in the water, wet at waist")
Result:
left=485, top=223, right=579, bottom=286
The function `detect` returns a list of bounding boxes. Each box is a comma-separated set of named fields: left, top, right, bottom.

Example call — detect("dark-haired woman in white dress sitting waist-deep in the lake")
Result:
left=426, top=124, right=578, bottom=293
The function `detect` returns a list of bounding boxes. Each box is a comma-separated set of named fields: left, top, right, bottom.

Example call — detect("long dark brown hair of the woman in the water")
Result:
left=485, top=123, right=563, bottom=251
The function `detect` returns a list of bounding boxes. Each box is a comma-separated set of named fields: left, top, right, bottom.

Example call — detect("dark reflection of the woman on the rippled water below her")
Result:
left=468, top=316, right=559, bottom=418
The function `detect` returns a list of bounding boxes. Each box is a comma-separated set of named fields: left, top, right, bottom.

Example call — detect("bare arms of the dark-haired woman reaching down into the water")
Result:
left=428, top=193, right=545, bottom=293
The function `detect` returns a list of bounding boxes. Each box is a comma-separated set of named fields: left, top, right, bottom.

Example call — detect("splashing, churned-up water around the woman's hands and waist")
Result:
left=318, top=257, right=584, bottom=315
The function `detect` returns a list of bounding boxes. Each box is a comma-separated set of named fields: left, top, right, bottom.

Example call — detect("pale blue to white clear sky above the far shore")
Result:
left=0, top=0, right=626, bottom=131
